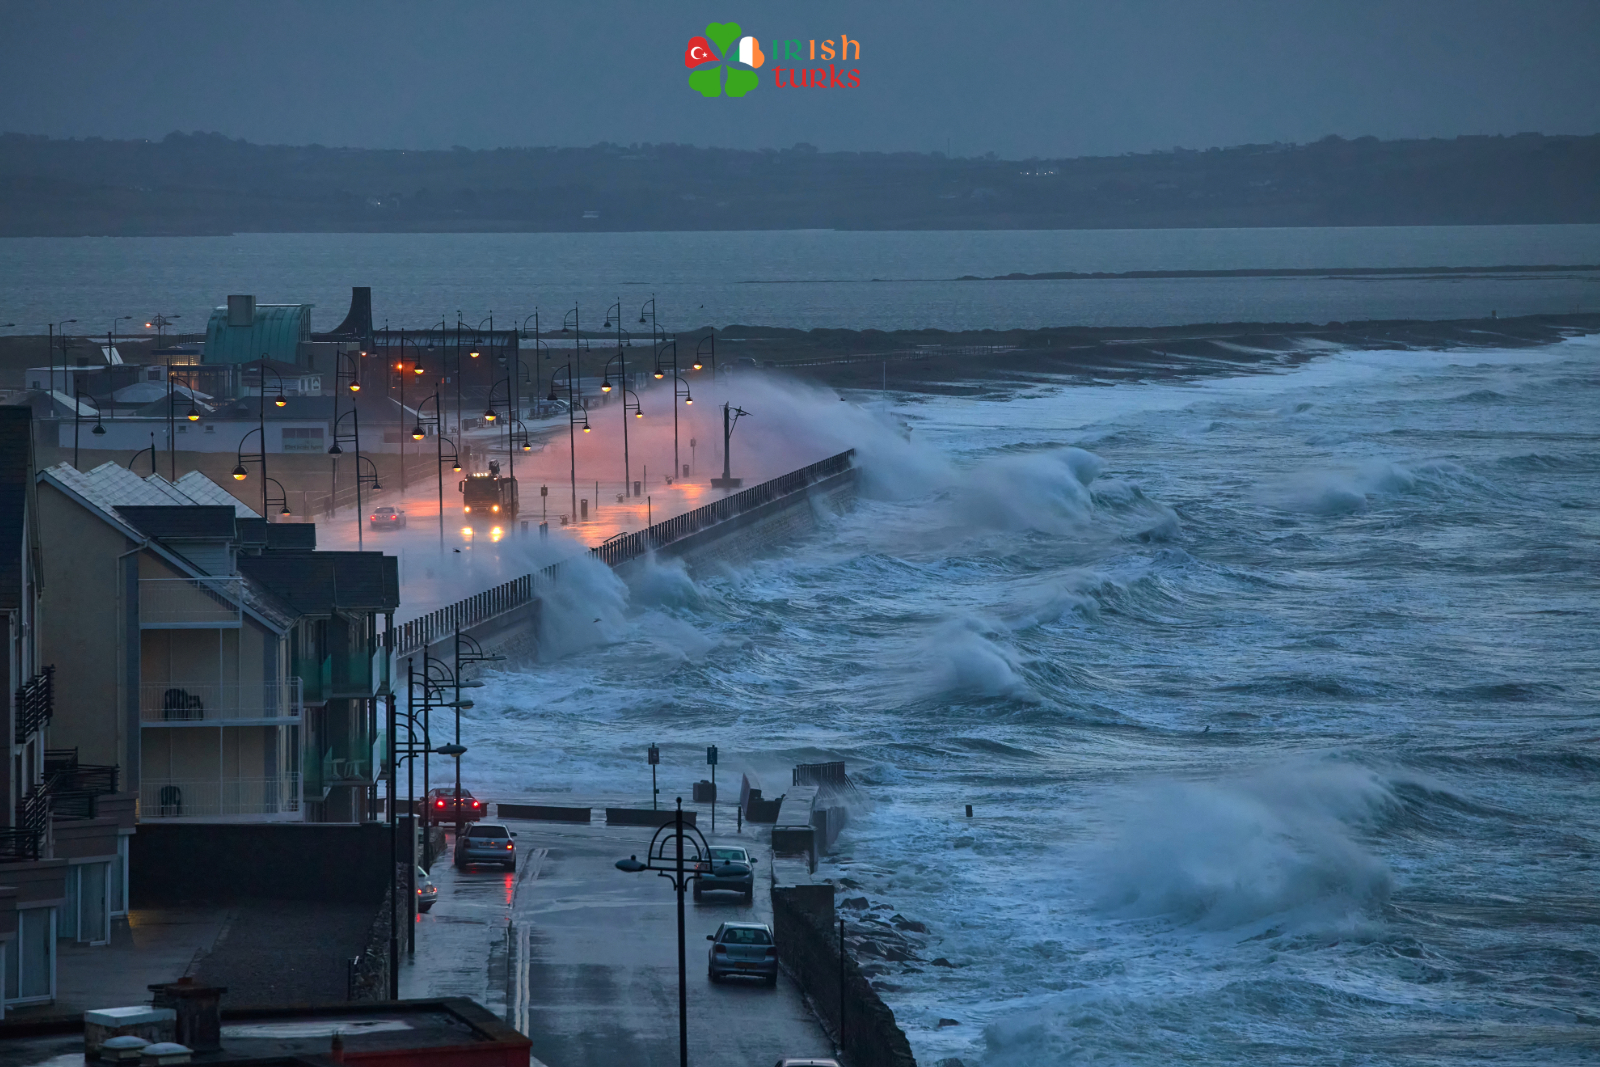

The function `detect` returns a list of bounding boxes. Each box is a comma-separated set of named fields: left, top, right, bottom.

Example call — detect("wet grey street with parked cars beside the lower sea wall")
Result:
left=400, top=816, right=834, bottom=1067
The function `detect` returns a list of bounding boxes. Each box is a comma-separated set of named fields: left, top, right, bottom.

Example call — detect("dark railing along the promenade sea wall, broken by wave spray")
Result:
left=392, top=448, right=856, bottom=656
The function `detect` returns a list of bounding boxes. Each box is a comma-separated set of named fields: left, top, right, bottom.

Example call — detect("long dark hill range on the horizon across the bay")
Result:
left=0, top=133, right=1600, bottom=237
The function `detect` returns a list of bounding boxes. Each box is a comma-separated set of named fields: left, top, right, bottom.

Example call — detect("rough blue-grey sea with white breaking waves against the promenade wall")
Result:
left=464, top=329, right=1600, bottom=1067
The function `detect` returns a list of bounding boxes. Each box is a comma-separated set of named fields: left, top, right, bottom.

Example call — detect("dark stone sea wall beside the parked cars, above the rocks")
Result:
left=773, top=885, right=917, bottom=1067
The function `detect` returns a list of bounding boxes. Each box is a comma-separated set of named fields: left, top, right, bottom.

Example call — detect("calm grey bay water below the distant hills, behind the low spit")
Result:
left=0, top=226, right=1600, bottom=333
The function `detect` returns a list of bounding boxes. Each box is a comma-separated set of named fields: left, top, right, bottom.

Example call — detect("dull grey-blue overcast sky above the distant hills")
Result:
left=0, top=0, right=1600, bottom=158
